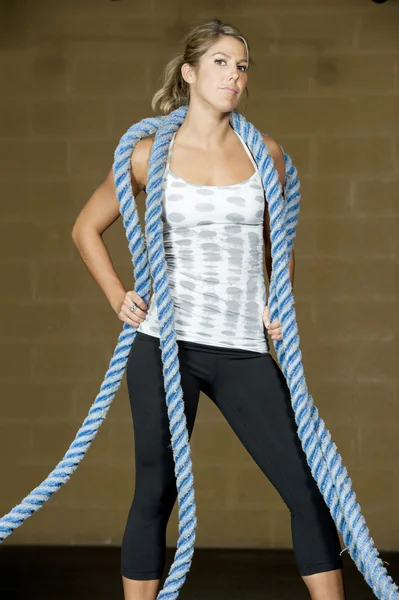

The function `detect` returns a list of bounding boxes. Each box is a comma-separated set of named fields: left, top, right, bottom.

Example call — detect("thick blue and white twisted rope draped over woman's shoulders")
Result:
left=0, top=107, right=399, bottom=600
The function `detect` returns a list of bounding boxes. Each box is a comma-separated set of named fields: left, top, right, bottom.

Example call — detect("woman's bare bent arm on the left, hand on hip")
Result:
left=72, top=138, right=152, bottom=324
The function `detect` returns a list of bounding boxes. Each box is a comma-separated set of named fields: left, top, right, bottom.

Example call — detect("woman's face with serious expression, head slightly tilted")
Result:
left=183, top=36, right=248, bottom=112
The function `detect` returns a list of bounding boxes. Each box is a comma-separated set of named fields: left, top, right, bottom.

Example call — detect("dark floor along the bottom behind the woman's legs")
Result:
left=0, top=544, right=399, bottom=600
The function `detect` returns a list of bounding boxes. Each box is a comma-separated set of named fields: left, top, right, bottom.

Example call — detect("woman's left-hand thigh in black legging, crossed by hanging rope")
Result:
left=126, top=332, right=200, bottom=484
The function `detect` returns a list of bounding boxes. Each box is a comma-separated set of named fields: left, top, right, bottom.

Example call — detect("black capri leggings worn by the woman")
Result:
left=121, top=331, right=343, bottom=580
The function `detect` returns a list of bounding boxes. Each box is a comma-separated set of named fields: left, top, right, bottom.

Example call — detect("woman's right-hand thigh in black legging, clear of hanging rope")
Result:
left=210, top=353, right=324, bottom=512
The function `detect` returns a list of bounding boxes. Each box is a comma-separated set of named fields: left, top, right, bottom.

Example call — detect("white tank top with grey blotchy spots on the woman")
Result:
left=137, top=132, right=269, bottom=353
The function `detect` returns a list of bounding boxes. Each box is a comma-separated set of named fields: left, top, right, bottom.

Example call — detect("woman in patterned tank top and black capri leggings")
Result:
left=73, top=20, right=344, bottom=600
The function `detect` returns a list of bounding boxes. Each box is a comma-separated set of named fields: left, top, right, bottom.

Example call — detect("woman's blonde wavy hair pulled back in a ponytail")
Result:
left=151, top=19, right=253, bottom=115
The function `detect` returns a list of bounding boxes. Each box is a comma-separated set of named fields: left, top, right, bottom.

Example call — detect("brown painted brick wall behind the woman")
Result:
left=0, top=0, right=399, bottom=550
